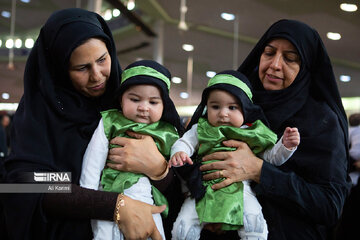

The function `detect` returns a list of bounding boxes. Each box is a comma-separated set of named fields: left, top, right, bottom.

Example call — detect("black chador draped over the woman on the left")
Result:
left=3, top=9, right=121, bottom=239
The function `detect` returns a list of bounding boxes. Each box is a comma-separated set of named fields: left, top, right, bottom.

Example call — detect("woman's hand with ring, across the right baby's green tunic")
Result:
left=200, top=140, right=263, bottom=190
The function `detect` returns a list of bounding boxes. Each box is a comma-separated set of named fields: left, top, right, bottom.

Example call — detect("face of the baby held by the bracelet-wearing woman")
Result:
left=121, top=85, right=164, bottom=123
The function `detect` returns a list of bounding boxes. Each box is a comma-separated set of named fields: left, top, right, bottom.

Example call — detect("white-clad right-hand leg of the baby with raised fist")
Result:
left=238, top=181, right=268, bottom=240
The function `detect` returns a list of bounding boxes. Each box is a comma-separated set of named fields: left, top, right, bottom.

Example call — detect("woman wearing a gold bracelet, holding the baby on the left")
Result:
left=1, top=9, right=174, bottom=239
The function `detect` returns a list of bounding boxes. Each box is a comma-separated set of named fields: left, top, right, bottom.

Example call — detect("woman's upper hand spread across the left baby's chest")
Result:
left=107, top=132, right=168, bottom=180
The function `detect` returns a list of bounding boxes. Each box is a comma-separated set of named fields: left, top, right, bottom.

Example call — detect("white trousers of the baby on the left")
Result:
left=91, top=177, right=165, bottom=240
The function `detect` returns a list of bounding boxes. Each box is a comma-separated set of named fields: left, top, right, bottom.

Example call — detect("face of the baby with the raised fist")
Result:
left=206, top=90, right=244, bottom=127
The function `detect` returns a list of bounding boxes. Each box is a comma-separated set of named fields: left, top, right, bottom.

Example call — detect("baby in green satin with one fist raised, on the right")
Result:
left=169, top=70, right=300, bottom=239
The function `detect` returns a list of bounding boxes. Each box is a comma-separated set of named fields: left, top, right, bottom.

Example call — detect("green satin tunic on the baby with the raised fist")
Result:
left=196, top=118, right=277, bottom=230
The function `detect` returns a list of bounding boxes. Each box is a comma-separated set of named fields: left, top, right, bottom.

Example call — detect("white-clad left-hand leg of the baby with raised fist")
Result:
left=171, top=197, right=202, bottom=240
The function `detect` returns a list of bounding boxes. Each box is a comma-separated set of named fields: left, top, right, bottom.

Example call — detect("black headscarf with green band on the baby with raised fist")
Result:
left=188, top=70, right=268, bottom=129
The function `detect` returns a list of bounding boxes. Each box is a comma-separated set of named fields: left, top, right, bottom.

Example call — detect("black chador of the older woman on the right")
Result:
left=238, top=20, right=350, bottom=239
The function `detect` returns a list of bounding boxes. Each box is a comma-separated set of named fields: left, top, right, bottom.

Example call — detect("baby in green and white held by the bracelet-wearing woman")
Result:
left=80, top=60, right=182, bottom=239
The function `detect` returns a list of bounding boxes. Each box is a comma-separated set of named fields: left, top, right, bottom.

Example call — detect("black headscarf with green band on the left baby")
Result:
left=116, top=60, right=184, bottom=136
